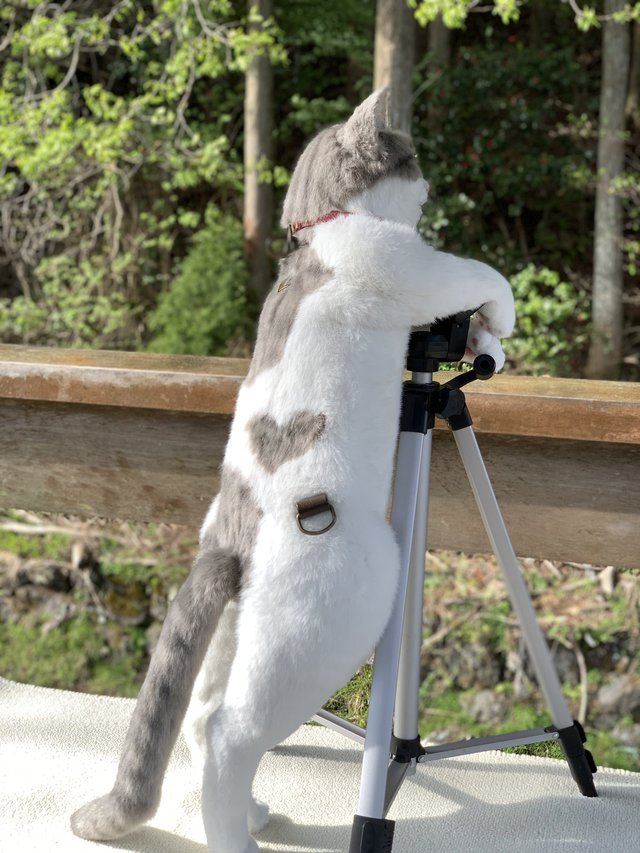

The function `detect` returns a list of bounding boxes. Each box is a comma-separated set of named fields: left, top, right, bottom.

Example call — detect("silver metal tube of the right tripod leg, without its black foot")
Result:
left=453, top=426, right=573, bottom=729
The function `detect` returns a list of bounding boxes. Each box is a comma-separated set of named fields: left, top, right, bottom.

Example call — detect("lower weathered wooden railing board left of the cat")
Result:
left=0, top=400, right=226, bottom=525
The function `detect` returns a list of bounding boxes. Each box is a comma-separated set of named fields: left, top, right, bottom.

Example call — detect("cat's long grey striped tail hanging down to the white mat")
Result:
left=71, top=534, right=240, bottom=841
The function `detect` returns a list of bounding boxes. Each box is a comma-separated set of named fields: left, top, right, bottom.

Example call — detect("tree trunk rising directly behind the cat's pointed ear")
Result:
left=373, top=0, right=415, bottom=133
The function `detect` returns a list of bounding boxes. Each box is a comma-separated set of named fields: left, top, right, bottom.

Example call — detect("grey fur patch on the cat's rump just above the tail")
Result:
left=216, top=468, right=263, bottom=560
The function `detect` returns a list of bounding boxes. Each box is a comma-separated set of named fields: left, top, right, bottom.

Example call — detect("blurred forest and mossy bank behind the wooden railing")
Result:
left=0, top=0, right=640, bottom=769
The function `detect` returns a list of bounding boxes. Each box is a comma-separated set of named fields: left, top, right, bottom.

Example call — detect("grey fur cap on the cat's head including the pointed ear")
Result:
left=280, top=93, right=422, bottom=228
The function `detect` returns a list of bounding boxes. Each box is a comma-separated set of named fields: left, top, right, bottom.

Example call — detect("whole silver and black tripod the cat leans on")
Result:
left=314, top=312, right=597, bottom=853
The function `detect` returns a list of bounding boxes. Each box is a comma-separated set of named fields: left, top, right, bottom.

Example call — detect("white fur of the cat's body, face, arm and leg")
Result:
left=186, top=179, right=514, bottom=853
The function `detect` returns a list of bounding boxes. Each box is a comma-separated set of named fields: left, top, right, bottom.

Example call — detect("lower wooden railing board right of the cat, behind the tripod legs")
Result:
left=429, top=432, right=640, bottom=567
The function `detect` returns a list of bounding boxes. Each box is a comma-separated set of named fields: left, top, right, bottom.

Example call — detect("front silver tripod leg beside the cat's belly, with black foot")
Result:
left=349, top=432, right=424, bottom=853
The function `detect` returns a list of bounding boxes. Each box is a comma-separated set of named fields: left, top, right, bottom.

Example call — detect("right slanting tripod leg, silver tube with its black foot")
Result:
left=453, top=426, right=597, bottom=797
